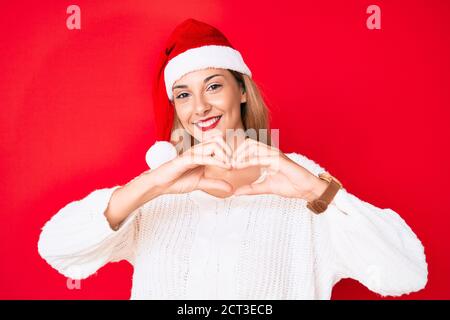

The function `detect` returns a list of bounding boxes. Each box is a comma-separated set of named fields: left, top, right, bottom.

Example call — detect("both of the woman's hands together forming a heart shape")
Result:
left=151, top=136, right=325, bottom=201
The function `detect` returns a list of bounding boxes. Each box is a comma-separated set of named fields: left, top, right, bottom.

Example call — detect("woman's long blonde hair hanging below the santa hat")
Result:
left=171, top=69, right=271, bottom=151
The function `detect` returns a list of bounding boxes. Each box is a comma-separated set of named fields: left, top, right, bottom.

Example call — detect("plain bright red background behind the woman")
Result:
left=0, top=0, right=450, bottom=299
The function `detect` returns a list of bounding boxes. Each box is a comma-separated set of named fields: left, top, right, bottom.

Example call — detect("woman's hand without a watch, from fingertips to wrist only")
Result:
left=149, top=135, right=233, bottom=194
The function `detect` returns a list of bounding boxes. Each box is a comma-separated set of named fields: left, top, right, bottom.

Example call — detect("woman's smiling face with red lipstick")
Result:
left=172, top=68, right=247, bottom=141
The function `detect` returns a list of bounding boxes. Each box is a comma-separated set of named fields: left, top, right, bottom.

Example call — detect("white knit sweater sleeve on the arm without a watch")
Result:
left=38, top=186, right=140, bottom=279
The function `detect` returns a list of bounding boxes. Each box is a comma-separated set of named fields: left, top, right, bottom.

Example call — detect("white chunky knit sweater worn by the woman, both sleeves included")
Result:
left=38, top=153, right=428, bottom=299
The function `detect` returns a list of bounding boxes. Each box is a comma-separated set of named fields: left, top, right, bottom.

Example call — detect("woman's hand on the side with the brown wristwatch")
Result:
left=232, top=139, right=326, bottom=201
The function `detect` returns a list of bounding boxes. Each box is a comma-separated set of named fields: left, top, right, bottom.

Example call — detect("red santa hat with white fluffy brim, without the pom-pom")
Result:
left=152, top=19, right=252, bottom=141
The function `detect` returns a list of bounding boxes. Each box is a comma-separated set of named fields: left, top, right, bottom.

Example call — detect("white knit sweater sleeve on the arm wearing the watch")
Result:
left=288, top=154, right=428, bottom=296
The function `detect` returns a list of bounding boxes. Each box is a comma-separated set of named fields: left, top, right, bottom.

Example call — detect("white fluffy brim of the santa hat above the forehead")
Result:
left=164, top=45, right=252, bottom=101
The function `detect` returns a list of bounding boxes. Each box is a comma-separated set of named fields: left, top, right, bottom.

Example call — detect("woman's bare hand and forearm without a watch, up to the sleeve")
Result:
left=105, top=136, right=233, bottom=230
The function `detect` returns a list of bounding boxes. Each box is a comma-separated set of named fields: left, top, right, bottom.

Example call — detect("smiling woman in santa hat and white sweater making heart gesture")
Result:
left=38, top=19, right=428, bottom=299
